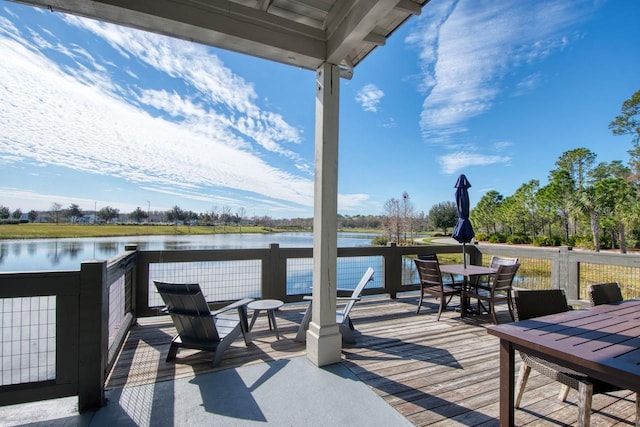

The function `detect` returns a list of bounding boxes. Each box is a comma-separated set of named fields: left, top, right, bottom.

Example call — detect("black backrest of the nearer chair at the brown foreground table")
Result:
left=512, top=289, right=569, bottom=320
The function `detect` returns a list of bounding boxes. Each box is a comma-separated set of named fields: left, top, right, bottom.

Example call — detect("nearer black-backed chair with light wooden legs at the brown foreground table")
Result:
left=513, top=289, right=640, bottom=426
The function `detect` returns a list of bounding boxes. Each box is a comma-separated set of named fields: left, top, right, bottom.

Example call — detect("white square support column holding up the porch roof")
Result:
left=307, top=63, right=342, bottom=366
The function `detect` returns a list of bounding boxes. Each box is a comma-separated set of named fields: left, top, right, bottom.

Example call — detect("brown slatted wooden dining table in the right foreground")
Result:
left=487, top=300, right=640, bottom=426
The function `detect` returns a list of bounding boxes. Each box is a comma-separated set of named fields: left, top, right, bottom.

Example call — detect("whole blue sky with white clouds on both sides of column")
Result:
left=0, top=0, right=640, bottom=218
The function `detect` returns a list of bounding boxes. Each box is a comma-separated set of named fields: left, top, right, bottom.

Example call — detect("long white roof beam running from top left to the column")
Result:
left=24, top=0, right=326, bottom=70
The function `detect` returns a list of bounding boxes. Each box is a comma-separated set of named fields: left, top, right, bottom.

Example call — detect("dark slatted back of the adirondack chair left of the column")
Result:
left=154, top=282, right=220, bottom=345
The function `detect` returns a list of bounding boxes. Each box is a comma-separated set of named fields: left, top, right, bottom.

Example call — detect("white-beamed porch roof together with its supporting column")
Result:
left=6, top=0, right=429, bottom=366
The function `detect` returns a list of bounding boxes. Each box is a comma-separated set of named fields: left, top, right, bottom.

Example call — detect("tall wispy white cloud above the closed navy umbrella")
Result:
left=407, top=0, right=594, bottom=173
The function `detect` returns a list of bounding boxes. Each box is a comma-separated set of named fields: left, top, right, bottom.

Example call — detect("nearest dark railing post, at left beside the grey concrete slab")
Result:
left=78, top=260, right=109, bottom=412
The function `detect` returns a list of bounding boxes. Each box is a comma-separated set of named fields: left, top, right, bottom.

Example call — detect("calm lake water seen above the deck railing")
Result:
left=0, top=232, right=376, bottom=272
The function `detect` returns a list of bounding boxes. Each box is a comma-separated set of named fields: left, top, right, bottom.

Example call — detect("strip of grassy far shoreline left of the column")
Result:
left=0, top=223, right=292, bottom=240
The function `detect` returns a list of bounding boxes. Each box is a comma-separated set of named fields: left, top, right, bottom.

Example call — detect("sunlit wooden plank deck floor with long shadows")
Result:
left=107, top=294, right=635, bottom=426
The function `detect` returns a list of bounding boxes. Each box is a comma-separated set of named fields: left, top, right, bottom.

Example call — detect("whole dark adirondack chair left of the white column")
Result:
left=153, top=281, right=253, bottom=367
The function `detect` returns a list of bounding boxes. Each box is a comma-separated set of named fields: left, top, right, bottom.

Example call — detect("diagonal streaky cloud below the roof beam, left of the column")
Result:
left=65, top=15, right=301, bottom=160
